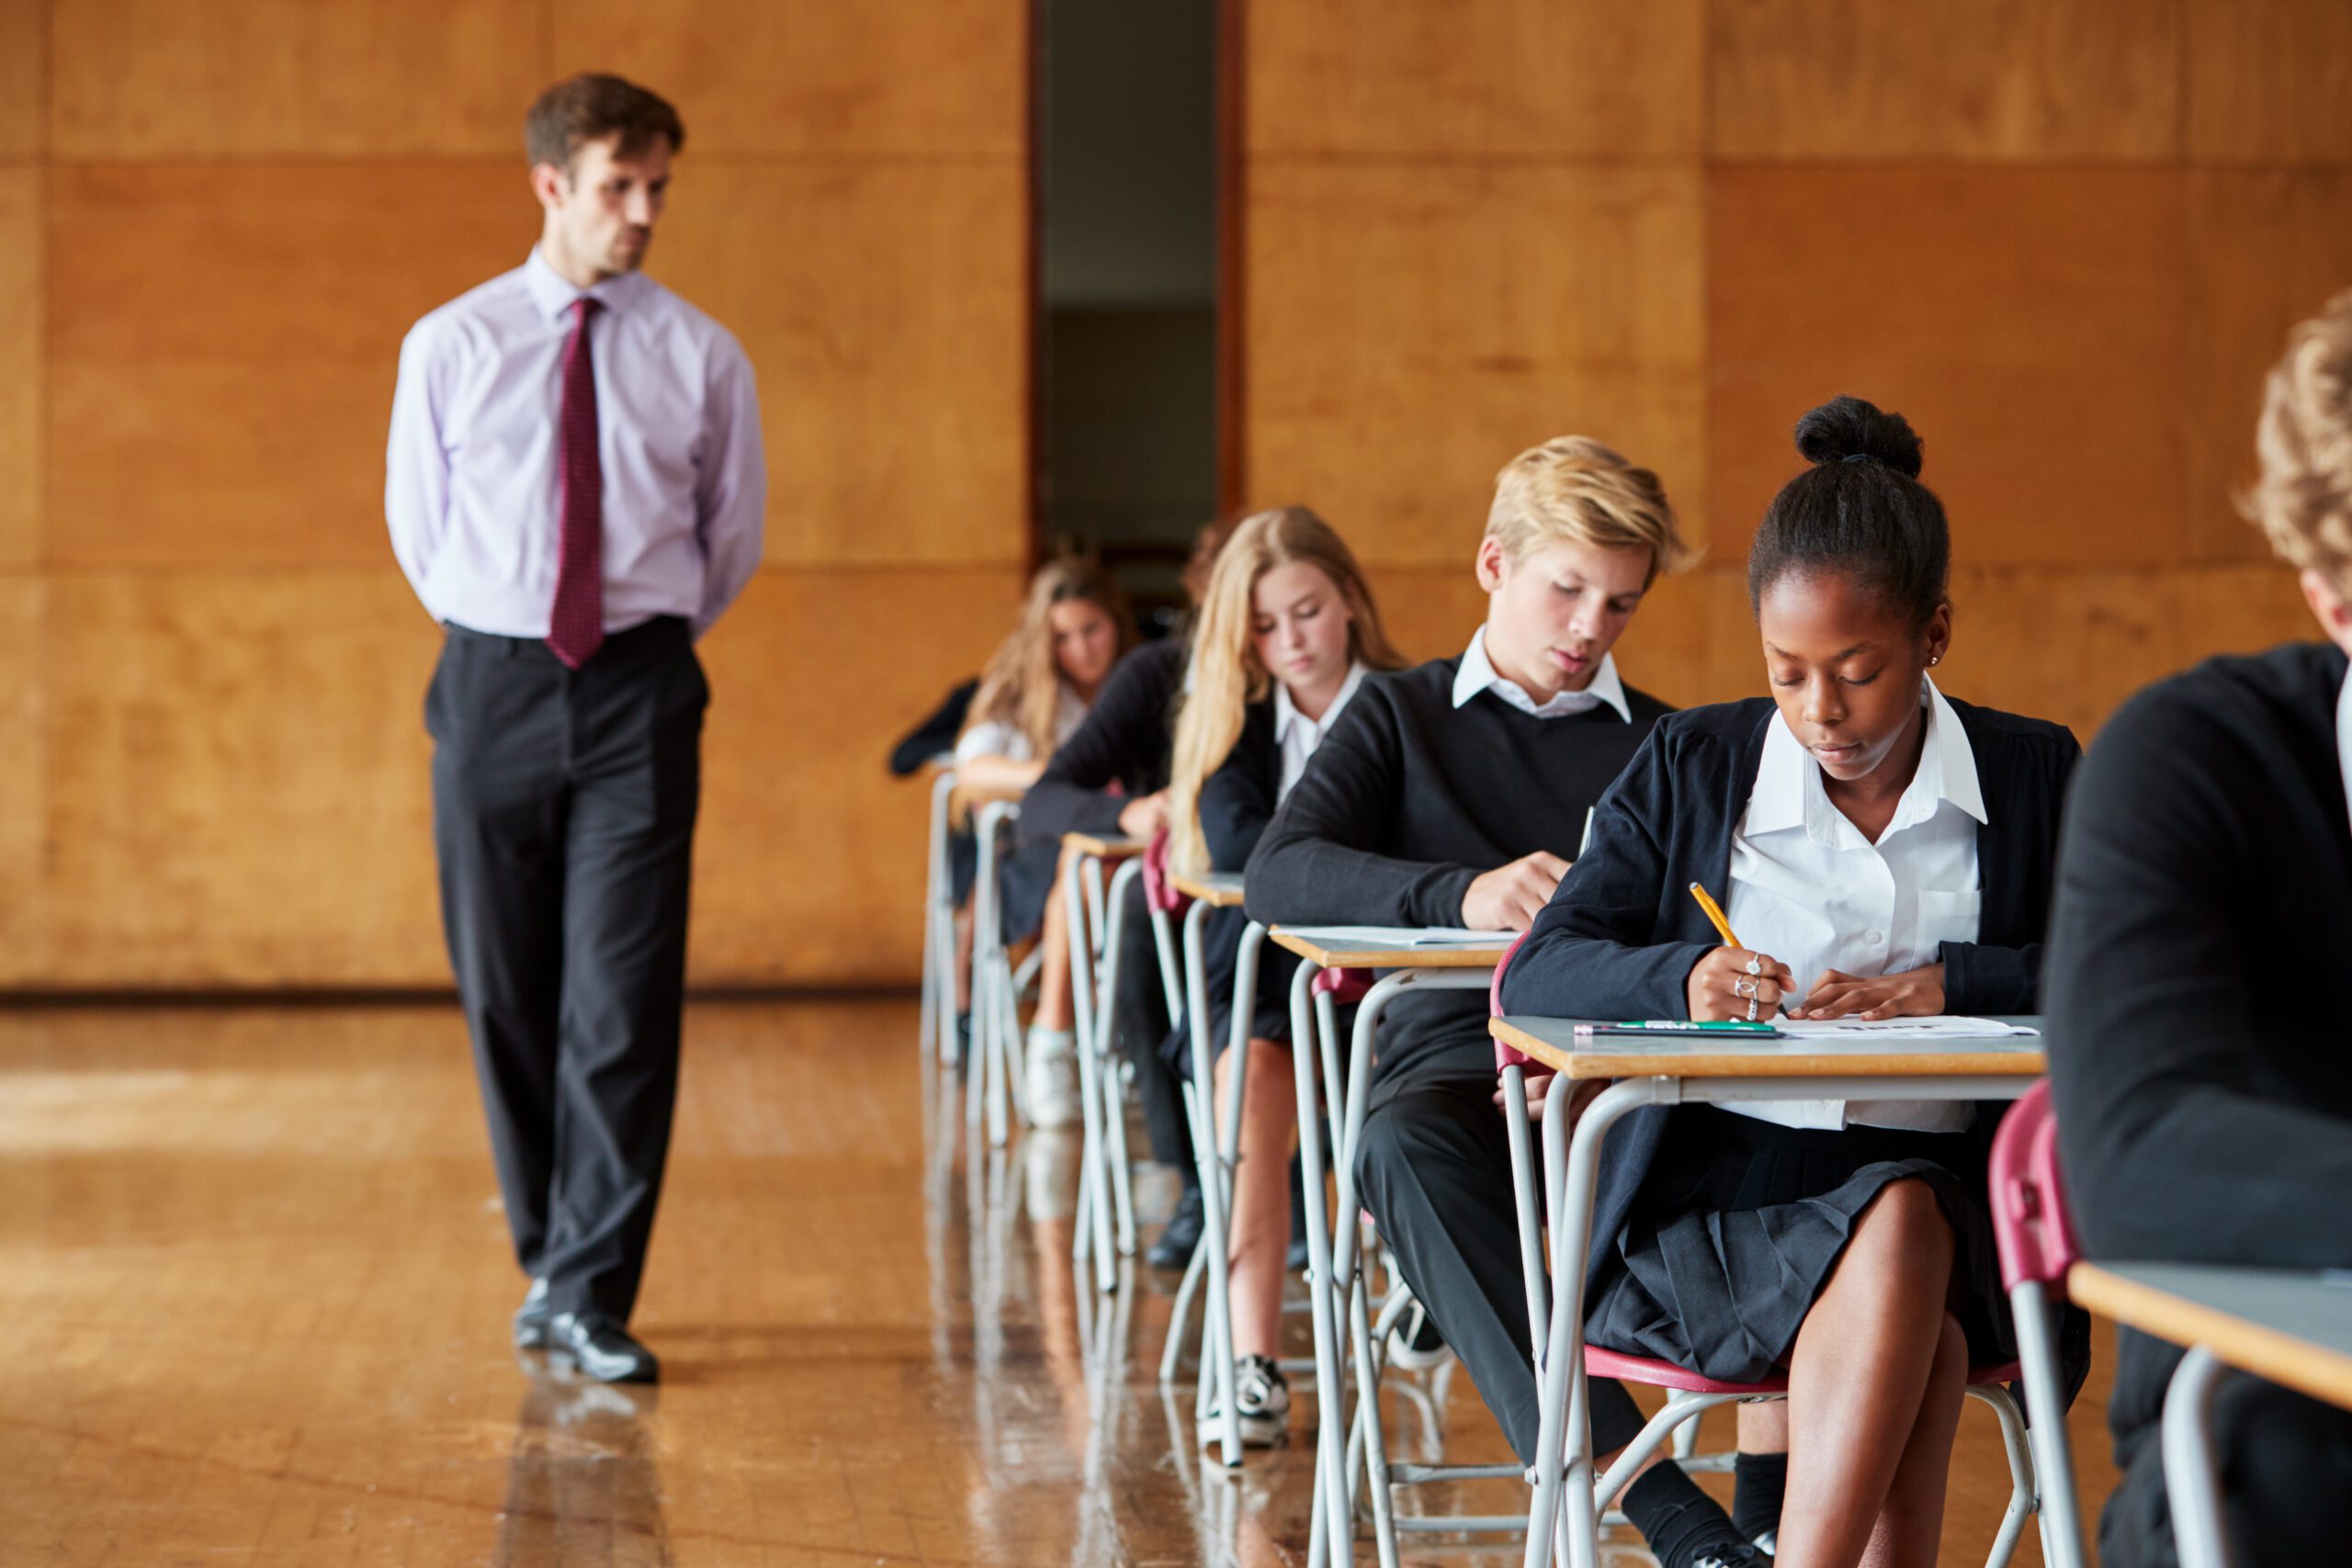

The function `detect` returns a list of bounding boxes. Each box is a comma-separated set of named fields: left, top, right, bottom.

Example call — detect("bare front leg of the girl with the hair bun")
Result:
left=1781, top=1180, right=1952, bottom=1568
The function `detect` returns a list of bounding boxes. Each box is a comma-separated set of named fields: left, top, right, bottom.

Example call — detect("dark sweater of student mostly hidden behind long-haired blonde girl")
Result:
left=1021, top=637, right=1185, bottom=841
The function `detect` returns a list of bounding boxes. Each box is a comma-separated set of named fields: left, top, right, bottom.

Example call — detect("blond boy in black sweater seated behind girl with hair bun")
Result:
left=1244, top=434, right=1769, bottom=1561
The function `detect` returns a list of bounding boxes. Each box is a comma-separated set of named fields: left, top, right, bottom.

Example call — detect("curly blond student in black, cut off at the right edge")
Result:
left=2049, top=294, right=2352, bottom=1568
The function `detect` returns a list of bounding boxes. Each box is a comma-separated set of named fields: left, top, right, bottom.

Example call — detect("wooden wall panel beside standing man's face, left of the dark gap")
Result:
left=656, top=164, right=1028, bottom=567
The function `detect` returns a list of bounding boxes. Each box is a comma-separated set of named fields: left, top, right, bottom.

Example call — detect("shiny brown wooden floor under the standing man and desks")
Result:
left=0, top=1001, right=2109, bottom=1568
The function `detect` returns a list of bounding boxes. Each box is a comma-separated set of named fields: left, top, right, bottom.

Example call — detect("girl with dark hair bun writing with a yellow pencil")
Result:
left=1503, top=398, right=2088, bottom=1568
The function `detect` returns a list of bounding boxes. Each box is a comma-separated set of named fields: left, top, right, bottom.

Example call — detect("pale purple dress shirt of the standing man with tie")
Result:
left=383, top=249, right=767, bottom=637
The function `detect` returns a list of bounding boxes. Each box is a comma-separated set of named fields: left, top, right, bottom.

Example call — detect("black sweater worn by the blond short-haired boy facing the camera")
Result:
left=1244, top=656, right=1670, bottom=1079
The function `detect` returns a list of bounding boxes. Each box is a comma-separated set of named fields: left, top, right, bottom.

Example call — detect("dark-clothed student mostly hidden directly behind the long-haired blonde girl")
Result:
left=1021, top=522, right=1232, bottom=1232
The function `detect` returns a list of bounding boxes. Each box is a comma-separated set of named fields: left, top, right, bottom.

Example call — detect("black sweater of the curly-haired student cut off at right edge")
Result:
left=2046, top=644, right=2352, bottom=1464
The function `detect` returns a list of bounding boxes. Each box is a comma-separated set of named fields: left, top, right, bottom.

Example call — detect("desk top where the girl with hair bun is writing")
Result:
left=1487, top=1016, right=2049, bottom=1079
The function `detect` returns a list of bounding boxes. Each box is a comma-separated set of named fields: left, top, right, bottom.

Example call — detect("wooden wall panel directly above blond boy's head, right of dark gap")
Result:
left=1244, top=164, right=1705, bottom=567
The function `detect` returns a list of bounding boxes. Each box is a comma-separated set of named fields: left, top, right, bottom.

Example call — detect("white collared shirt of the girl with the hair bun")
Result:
left=1724, top=682, right=1985, bottom=1134
